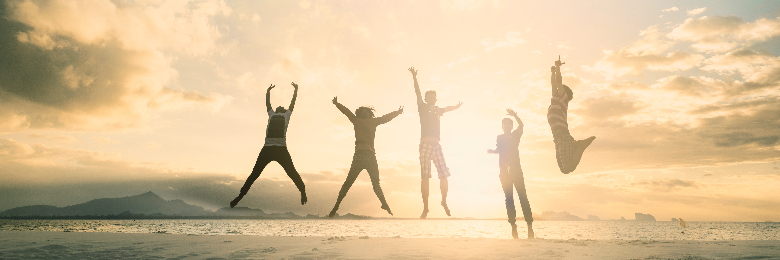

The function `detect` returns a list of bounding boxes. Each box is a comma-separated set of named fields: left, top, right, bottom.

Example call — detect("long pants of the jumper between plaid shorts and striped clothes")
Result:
left=498, top=163, right=534, bottom=224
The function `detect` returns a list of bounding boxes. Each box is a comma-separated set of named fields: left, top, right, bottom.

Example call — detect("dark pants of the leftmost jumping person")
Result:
left=241, top=146, right=306, bottom=195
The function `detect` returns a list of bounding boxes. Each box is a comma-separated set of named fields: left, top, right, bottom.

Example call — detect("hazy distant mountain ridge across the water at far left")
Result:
left=0, top=191, right=213, bottom=217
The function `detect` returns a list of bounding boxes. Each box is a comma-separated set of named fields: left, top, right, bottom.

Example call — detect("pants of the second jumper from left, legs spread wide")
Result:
left=333, top=150, right=387, bottom=209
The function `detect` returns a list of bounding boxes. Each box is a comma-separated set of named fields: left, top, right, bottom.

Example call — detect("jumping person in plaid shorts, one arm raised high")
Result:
left=409, top=67, right=463, bottom=218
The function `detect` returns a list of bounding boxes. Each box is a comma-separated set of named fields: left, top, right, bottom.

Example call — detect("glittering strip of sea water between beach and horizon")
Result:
left=0, top=219, right=780, bottom=240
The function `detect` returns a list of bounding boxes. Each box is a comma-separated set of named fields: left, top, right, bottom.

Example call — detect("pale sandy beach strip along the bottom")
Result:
left=0, top=231, right=780, bottom=259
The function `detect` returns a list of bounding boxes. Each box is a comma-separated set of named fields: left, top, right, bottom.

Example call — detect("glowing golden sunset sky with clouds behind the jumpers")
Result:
left=0, top=0, right=780, bottom=221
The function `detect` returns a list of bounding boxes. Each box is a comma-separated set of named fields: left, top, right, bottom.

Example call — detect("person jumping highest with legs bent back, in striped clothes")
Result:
left=547, top=56, right=596, bottom=174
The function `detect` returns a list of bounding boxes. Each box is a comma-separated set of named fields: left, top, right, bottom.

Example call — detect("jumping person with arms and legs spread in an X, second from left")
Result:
left=328, top=97, right=404, bottom=218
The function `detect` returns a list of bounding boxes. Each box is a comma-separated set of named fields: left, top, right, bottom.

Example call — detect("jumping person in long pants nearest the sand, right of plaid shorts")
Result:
left=488, top=108, right=534, bottom=238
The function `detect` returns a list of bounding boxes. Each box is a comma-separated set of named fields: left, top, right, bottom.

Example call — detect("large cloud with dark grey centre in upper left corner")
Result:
left=0, top=1, right=232, bottom=131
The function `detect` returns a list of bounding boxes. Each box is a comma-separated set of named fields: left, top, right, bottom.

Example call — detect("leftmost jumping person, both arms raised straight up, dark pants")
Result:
left=230, top=82, right=307, bottom=208
